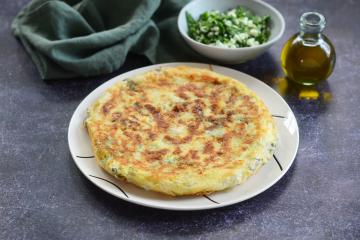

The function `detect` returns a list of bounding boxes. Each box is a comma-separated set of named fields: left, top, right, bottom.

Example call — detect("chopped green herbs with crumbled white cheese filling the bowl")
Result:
left=186, top=7, right=270, bottom=48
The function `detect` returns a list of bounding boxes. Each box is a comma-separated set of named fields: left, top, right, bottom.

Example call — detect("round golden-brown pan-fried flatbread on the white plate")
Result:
left=85, top=66, right=277, bottom=196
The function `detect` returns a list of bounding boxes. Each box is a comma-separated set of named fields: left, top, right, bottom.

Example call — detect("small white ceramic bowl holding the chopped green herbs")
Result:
left=178, top=0, right=285, bottom=64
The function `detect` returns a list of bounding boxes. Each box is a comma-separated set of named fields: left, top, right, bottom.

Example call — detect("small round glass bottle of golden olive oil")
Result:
left=281, top=12, right=335, bottom=85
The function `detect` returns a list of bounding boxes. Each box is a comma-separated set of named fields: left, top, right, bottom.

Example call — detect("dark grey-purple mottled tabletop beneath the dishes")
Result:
left=0, top=0, right=360, bottom=239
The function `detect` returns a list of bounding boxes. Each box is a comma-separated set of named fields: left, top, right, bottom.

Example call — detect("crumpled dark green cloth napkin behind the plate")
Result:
left=12, top=0, right=200, bottom=79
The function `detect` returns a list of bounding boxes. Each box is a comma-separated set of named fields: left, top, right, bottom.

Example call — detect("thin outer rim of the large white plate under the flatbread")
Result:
left=67, top=62, right=300, bottom=211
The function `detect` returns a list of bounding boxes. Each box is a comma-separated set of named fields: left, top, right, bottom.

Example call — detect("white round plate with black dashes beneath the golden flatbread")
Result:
left=68, top=63, right=299, bottom=210
